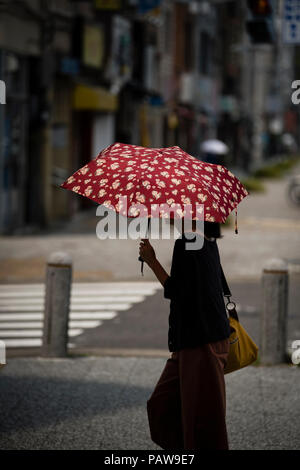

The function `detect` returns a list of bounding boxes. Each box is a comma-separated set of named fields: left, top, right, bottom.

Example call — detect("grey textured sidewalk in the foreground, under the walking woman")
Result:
left=0, top=357, right=300, bottom=450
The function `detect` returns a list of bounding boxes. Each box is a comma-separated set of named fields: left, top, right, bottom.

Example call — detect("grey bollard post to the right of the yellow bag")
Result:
left=260, top=258, right=289, bottom=365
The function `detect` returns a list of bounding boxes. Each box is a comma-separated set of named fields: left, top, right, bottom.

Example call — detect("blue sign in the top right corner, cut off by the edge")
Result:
left=282, top=0, right=300, bottom=44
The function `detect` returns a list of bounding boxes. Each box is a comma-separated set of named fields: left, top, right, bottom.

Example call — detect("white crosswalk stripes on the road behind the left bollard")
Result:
left=0, top=281, right=162, bottom=348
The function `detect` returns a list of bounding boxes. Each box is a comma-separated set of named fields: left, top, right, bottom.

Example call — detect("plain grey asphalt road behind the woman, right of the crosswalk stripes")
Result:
left=72, top=274, right=300, bottom=354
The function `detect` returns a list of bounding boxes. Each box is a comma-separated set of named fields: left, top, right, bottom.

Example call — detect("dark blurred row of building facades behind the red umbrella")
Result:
left=0, top=0, right=299, bottom=233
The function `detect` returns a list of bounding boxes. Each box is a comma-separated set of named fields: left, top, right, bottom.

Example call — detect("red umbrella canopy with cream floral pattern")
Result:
left=61, top=143, right=248, bottom=222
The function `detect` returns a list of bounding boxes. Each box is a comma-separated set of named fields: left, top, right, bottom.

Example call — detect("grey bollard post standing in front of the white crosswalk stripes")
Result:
left=42, top=252, right=72, bottom=357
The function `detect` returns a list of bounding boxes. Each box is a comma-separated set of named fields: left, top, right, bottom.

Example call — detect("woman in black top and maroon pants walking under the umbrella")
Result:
left=140, top=221, right=230, bottom=450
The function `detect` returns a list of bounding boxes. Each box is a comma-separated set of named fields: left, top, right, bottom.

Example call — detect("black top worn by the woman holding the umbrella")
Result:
left=164, top=234, right=230, bottom=352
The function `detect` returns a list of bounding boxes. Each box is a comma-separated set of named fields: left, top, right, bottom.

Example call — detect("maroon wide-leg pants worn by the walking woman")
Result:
left=147, top=339, right=229, bottom=450
